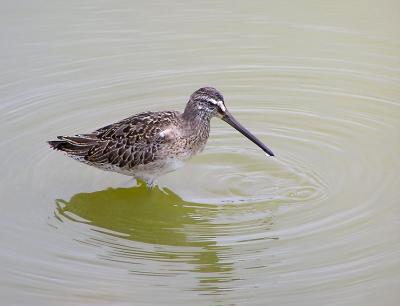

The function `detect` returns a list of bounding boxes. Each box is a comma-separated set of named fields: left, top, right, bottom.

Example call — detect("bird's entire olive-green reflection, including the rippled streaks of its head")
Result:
left=56, top=185, right=233, bottom=293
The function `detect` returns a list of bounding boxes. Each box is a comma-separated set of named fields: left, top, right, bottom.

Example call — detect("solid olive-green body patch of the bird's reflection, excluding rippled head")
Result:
left=56, top=185, right=206, bottom=246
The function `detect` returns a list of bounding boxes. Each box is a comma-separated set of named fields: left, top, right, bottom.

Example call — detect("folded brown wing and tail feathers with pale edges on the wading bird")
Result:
left=49, top=112, right=179, bottom=168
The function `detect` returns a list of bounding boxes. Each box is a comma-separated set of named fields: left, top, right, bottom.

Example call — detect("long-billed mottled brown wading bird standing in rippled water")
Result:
left=49, top=87, right=274, bottom=188
